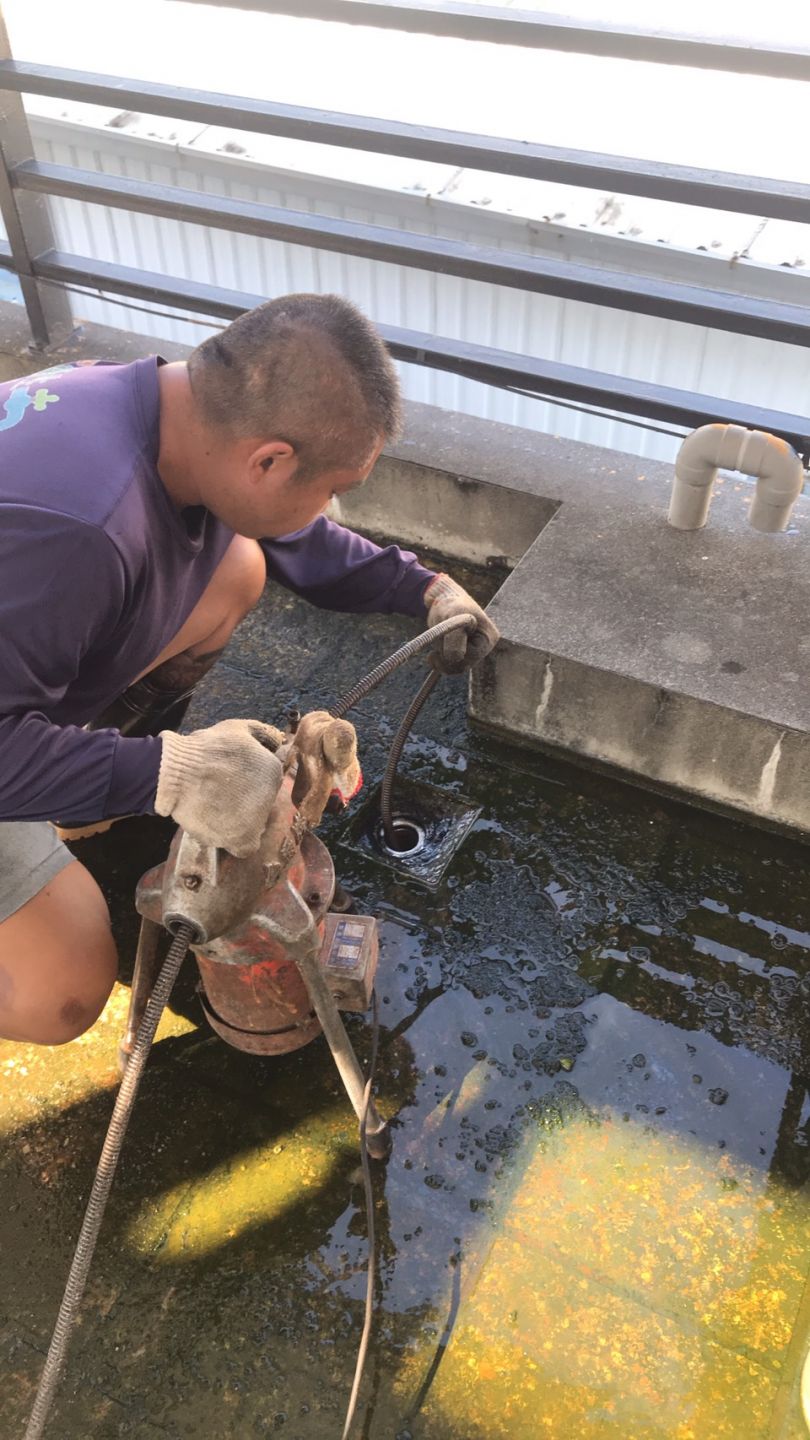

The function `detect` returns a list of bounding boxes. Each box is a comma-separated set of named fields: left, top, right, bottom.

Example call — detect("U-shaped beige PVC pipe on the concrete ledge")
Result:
left=667, top=425, right=804, bottom=534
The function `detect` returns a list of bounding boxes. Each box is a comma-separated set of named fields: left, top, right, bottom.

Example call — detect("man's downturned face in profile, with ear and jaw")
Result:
left=209, top=439, right=383, bottom=540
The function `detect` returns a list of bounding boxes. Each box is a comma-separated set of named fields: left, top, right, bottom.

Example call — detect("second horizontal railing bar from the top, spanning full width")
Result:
left=0, top=60, right=810, bottom=223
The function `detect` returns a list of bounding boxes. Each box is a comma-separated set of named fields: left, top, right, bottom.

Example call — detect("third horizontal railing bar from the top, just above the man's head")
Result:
left=12, top=160, right=810, bottom=346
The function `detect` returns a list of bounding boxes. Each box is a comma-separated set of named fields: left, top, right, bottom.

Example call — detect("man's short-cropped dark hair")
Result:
left=189, top=295, right=401, bottom=480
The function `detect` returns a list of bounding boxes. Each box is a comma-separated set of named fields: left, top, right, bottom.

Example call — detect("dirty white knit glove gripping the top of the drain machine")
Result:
left=154, top=720, right=282, bottom=855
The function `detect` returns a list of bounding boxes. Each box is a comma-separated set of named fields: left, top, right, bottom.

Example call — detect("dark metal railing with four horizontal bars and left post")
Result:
left=0, top=0, right=810, bottom=456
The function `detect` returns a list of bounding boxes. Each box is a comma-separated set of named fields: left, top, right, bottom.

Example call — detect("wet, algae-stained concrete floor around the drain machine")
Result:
left=0, top=564, right=810, bottom=1440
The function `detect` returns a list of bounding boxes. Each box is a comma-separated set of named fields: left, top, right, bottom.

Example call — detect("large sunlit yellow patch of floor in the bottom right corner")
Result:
left=401, top=1116, right=810, bottom=1440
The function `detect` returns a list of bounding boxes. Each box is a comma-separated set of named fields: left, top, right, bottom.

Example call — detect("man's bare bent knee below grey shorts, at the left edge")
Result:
left=0, top=861, right=118, bottom=1045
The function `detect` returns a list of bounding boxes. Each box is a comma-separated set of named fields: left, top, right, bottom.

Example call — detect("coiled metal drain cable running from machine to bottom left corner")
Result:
left=25, top=924, right=195, bottom=1440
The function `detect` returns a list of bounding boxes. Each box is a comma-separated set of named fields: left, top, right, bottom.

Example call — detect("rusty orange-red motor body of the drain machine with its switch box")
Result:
left=135, top=786, right=378, bottom=1056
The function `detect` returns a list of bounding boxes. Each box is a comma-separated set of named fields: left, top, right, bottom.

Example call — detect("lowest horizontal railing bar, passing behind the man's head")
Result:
left=17, top=249, right=810, bottom=458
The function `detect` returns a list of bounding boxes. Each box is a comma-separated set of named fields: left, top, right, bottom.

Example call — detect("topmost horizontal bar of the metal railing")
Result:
left=167, top=0, right=810, bottom=81
